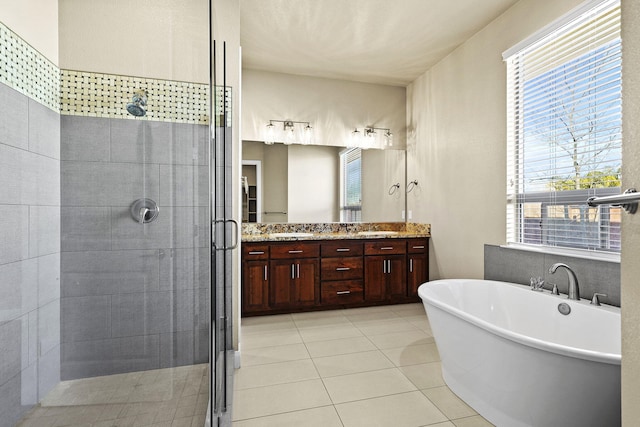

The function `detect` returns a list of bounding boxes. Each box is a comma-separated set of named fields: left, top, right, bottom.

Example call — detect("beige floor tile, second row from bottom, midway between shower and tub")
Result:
left=322, top=368, right=417, bottom=403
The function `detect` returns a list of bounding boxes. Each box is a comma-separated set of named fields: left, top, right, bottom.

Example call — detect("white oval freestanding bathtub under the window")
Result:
left=418, top=279, right=621, bottom=427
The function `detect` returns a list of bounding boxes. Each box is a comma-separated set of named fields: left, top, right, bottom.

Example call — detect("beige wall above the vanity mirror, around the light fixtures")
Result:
left=242, top=70, right=406, bottom=148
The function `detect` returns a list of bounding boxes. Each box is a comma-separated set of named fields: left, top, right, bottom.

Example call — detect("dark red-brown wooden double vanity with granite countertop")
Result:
left=242, top=224, right=429, bottom=316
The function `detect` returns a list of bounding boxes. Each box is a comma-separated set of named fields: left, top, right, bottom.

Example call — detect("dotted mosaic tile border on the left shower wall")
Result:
left=0, top=22, right=60, bottom=112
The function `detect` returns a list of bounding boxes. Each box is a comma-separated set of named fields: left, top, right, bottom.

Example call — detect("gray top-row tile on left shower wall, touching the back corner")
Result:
left=29, top=99, right=60, bottom=160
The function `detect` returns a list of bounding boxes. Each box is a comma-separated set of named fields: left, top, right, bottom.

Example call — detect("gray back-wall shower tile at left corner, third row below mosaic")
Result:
left=61, top=206, right=111, bottom=252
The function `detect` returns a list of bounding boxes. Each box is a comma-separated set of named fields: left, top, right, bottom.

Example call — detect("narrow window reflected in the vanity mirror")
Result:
left=340, top=148, right=362, bottom=222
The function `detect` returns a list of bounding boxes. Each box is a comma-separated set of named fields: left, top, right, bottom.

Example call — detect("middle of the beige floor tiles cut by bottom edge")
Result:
left=336, top=392, right=447, bottom=427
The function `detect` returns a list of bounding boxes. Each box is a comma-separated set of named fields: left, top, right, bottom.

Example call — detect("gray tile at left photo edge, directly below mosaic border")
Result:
left=0, top=83, right=29, bottom=150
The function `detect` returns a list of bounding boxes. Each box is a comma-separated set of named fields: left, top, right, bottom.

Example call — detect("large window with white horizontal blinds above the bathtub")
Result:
left=504, top=1, right=622, bottom=252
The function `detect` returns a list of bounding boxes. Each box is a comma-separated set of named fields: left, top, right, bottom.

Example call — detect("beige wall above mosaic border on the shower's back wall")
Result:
left=58, top=0, right=209, bottom=83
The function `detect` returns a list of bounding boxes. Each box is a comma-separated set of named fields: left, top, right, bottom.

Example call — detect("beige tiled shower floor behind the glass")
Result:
left=16, top=364, right=209, bottom=427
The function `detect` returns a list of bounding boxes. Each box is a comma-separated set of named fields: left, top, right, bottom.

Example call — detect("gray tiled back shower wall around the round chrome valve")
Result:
left=61, top=115, right=209, bottom=379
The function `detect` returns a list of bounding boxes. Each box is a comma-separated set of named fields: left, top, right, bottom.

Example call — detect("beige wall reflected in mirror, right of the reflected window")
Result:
left=362, top=150, right=406, bottom=222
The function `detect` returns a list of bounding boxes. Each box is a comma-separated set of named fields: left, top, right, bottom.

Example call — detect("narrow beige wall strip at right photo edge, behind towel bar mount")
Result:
left=621, top=0, right=640, bottom=427
